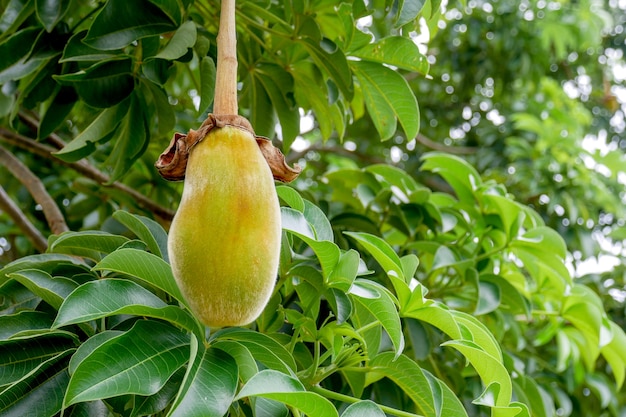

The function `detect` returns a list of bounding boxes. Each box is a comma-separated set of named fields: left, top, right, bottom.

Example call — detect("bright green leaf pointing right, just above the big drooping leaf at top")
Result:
left=353, top=36, right=429, bottom=74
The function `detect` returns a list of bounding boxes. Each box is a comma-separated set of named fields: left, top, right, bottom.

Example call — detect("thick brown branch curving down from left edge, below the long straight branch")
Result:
left=0, top=147, right=69, bottom=235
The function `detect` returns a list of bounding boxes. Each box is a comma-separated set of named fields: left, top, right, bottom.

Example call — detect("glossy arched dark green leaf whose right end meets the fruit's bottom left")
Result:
left=53, top=279, right=198, bottom=331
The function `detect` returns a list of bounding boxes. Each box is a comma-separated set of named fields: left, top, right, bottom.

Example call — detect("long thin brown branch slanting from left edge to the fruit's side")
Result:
left=0, top=127, right=174, bottom=221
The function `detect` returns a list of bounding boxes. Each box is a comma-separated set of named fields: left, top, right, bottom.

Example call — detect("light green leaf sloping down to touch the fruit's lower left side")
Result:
left=93, top=248, right=186, bottom=305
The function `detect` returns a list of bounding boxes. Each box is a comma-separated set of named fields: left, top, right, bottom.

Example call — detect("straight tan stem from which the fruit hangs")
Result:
left=213, top=0, right=239, bottom=116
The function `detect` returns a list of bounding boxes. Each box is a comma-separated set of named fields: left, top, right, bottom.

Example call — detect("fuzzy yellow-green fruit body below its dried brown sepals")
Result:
left=168, top=126, right=281, bottom=327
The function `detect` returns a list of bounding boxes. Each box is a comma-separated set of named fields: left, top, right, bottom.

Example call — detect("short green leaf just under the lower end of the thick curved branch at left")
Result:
left=49, top=230, right=129, bottom=261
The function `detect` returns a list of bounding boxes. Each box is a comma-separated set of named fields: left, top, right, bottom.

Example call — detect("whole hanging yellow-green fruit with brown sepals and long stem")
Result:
left=156, top=0, right=300, bottom=327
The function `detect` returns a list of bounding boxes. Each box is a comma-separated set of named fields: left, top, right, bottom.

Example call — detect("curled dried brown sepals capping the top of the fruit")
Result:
left=154, top=114, right=301, bottom=182
